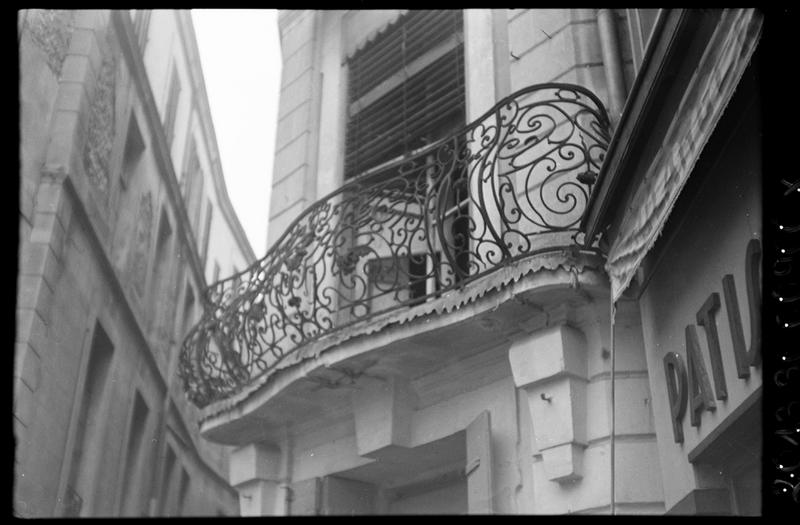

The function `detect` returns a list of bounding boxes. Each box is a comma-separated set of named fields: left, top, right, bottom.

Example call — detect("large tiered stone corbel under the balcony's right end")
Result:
left=508, top=324, right=588, bottom=483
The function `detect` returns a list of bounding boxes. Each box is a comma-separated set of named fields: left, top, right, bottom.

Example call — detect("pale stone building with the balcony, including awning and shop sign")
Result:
left=180, top=9, right=762, bottom=515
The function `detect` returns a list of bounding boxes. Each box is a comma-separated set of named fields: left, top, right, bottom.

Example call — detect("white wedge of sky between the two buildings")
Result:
left=192, top=9, right=281, bottom=258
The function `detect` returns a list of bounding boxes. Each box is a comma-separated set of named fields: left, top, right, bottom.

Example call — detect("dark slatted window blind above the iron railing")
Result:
left=345, top=11, right=466, bottom=178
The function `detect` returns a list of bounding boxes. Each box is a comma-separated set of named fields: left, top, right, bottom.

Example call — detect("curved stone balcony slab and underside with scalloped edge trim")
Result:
left=201, top=253, right=608, bottom=445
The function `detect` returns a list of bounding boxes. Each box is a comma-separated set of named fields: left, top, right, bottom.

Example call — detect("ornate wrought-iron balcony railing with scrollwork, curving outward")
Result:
left=179, top=84, right=610, bottom=406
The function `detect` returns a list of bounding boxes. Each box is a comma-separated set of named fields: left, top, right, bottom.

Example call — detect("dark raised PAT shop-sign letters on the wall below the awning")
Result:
left=664, top=239, right=761, bottom=443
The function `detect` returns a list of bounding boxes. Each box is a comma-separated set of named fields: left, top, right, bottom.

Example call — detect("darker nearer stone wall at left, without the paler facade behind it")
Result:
left=13, top=10, right=237, bottom=517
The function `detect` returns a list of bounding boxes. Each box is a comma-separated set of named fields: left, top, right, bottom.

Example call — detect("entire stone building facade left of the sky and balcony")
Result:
left=13, top=9, right=255, bottom=517
